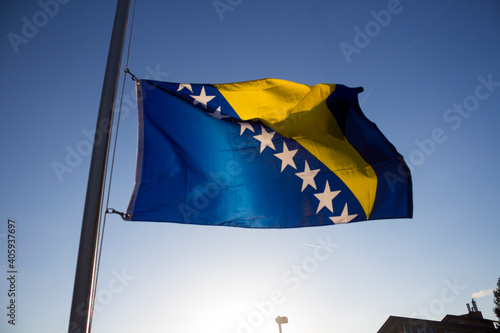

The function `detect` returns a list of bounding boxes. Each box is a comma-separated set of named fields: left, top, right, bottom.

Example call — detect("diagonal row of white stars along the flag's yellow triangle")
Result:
left=177, top=83, right=358, bottom=224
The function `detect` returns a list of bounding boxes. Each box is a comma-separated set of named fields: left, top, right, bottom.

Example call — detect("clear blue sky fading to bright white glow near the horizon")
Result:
left=0, top=0, right=500, bottom=333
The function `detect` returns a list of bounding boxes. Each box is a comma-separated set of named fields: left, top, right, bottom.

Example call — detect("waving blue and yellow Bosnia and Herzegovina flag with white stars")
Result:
left=127, top=79, right=413, bottom=228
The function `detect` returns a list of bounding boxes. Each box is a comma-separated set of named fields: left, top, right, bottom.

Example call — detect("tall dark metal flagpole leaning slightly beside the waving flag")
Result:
left=68, top=0, right=130, bottom=333
